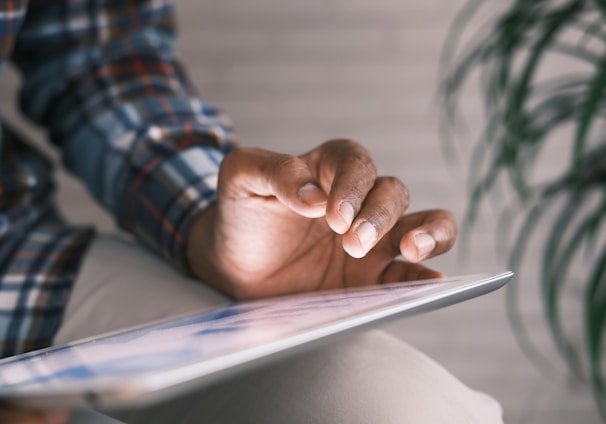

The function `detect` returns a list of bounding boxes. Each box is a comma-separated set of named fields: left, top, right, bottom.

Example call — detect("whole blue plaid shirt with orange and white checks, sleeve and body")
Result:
left=0, top=0, right=234, bottom=356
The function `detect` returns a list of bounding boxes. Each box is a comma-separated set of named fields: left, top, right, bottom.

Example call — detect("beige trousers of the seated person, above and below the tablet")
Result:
left=55, top=235, right=503, bottom=424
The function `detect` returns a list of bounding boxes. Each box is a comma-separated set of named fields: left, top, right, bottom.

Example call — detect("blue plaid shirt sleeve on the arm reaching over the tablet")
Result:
left=12, top=0, right=235, bottom=270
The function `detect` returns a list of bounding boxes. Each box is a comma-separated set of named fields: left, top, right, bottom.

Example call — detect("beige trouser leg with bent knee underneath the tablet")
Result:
left=118, top=331, right=502, bottom=424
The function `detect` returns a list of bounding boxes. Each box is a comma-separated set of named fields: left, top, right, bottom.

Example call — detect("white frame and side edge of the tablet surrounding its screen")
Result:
left=0, top=272, right=513, bottom=408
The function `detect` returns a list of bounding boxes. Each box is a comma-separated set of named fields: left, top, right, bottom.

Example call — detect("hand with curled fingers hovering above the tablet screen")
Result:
left=187, top=140, right=457, bottom=298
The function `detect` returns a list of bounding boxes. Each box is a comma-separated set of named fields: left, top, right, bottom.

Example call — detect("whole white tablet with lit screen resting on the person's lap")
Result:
left=0, top=272, right=513, bottom=409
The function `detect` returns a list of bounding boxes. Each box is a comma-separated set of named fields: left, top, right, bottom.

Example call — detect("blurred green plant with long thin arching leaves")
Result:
left=441, top=0, right=606, bottom=422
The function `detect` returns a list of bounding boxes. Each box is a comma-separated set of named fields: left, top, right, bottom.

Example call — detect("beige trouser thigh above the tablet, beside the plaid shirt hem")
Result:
left=54, top=234, right=229, bottom=344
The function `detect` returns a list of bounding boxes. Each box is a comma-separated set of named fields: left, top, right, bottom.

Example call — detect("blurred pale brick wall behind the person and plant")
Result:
left=0, top=0, right=599, bottom=424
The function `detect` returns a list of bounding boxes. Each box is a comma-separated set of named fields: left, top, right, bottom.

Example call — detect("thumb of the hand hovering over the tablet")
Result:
left=219, top=148, right=328, bottom=218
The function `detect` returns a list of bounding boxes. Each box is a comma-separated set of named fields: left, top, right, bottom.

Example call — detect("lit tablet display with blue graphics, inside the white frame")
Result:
left=0, top=282, right=447, bottom=396
